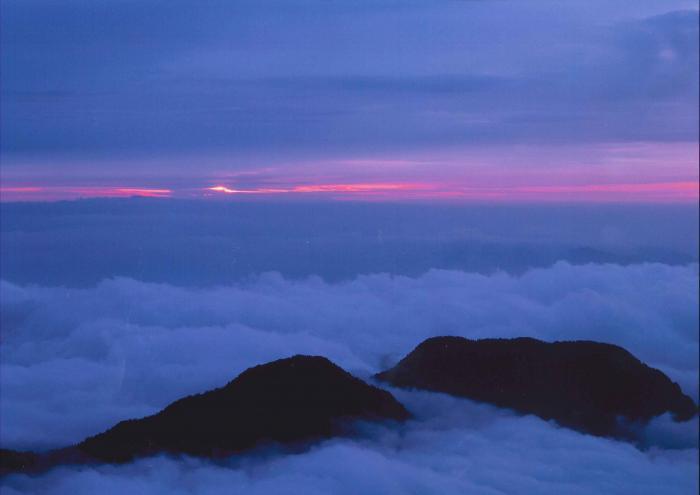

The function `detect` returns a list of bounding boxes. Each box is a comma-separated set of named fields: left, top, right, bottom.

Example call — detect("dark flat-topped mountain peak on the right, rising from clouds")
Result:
left=376, top=337, right=698, bottom=437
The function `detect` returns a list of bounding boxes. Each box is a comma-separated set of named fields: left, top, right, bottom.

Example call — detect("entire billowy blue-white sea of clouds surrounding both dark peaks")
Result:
left=0, top=262, right=698, bottom=494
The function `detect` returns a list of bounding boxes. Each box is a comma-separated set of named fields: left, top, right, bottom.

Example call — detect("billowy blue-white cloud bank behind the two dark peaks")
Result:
left=0, top=263, right=698, bottom=454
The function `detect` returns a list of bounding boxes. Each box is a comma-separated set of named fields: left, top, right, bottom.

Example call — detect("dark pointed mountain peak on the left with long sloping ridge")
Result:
left=0, top=356, right=409, bottom=472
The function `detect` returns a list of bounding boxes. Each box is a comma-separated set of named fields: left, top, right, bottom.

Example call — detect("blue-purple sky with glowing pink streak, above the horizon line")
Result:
left=0, top=0, right=698, bottom=204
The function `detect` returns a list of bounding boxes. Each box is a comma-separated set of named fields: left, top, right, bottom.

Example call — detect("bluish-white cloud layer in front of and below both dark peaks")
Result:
left=3, top=391, right=698, bottom=495
